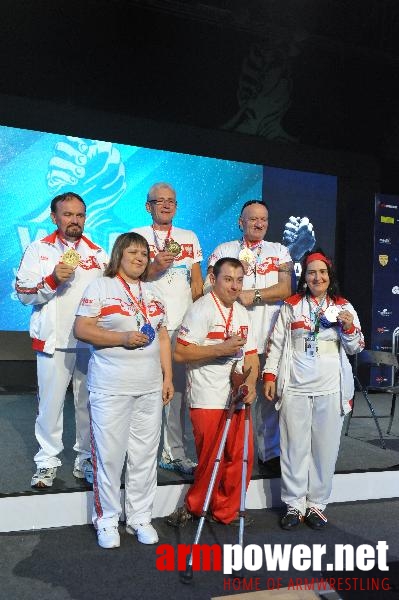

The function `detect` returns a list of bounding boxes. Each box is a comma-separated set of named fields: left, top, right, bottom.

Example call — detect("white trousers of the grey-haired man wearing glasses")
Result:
left=163, top=331, right=187, bottom=460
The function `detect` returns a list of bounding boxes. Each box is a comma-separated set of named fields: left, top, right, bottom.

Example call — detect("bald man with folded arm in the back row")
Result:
left=205, top=200, right=292, bottom=476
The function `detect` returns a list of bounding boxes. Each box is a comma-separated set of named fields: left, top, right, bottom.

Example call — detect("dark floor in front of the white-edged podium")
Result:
left=0, top=500, right=399, bottom=600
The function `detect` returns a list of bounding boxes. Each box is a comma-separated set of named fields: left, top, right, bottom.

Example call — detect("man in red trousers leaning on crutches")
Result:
left=166, top=258, right=259, bottom=527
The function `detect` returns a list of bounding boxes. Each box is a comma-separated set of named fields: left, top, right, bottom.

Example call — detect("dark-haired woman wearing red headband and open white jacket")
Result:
left=263, top=249, right=364, bottom=530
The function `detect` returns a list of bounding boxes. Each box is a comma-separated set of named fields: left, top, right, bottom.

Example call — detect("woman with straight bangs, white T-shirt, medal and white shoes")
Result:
left=75, top=232, right=173, bottom=548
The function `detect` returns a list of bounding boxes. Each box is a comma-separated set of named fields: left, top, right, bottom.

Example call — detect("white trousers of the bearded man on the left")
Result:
left=34, top=348, right=90, bottom=468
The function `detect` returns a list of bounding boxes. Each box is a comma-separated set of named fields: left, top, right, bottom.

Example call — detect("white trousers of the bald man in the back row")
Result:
left=255, top=354, right=280, bottom=462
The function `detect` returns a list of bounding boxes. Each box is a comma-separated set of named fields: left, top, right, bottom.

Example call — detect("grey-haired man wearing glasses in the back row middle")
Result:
left=134, top=182, right=203, bottom=475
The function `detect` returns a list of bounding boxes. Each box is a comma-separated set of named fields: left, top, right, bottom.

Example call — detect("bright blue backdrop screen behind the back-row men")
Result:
left=0, top=126, right=336, bottom=331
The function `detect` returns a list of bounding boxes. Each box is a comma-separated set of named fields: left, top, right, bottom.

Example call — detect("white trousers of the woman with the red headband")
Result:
left=280, top=392, right=344, bottom=514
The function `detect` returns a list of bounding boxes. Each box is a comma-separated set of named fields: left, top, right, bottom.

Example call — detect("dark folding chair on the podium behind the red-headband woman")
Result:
left=345, top=350, right=399, bottom=450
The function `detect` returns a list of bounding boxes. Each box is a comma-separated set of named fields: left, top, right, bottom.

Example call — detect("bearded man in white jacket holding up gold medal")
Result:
left=16, top=192, right=108, bottom=489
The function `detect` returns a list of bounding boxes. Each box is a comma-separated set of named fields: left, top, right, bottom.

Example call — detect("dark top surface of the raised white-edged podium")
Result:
left=0, top=390, right=399, bottom=497
